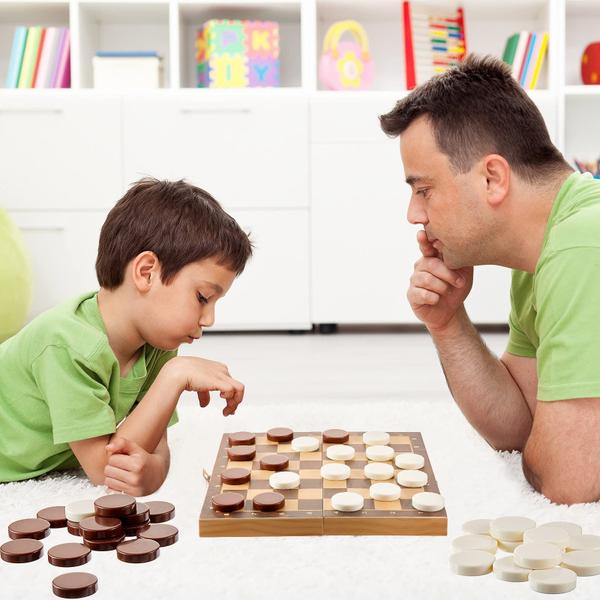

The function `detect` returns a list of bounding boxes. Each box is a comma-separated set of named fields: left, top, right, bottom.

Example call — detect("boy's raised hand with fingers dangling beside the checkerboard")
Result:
left=165, top=356, right=244, bottom=416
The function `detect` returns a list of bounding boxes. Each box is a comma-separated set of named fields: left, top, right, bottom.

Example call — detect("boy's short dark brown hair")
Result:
left=96, top=177, right=252, bottom=289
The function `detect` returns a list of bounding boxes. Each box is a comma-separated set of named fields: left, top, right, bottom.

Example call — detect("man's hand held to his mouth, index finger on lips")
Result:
left=406, top=229, right=473, bottom=331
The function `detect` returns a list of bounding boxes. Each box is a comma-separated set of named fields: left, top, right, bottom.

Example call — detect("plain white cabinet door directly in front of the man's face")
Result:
left=311, top=140, right=418, bottom=323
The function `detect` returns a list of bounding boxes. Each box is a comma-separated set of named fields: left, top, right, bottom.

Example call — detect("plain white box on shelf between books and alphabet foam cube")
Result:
left=93, top=56, right=162, bottom=90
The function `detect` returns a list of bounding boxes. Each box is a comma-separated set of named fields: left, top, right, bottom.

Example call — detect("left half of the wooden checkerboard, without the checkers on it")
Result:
left=199, top=432, right=323, bottom=537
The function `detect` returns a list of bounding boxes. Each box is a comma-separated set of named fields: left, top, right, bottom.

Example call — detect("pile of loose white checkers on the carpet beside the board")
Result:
left=450, top=517, right=600, bottom=594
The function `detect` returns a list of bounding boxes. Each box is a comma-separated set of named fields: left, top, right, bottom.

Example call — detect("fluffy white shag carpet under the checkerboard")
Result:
left=0, top=332, right=600, bottom=600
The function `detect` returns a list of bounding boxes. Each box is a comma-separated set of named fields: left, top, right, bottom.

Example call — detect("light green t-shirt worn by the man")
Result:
left=507, top=173, right=600, bottom=400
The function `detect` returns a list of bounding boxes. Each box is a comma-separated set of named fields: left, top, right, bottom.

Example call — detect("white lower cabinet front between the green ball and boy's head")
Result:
left=10, top=212, right=106, bottom=319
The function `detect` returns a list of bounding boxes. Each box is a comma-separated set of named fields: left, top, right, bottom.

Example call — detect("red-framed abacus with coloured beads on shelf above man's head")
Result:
left=402, top=0, right=467, bottom=90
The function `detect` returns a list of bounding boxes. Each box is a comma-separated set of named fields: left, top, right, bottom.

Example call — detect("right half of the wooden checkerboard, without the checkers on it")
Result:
left=323, top=432, right=448, bottom=535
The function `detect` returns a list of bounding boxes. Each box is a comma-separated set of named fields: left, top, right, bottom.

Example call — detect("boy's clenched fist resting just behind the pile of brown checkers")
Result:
left=104, top=437, right=167, bottom=496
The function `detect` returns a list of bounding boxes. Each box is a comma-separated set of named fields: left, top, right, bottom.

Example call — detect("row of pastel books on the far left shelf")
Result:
left=5, top=27, right=71, bottom=88
